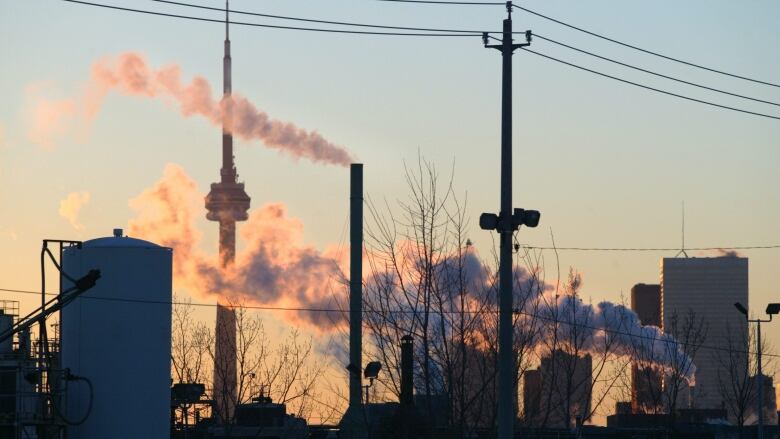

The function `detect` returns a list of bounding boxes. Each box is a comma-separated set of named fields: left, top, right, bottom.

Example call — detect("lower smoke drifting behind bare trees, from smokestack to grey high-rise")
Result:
left=366, top=241, right=696, bottom=384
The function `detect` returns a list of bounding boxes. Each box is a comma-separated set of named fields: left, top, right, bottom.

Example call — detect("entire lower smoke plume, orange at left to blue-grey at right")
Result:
left=129, top=165, right=695, bottom=382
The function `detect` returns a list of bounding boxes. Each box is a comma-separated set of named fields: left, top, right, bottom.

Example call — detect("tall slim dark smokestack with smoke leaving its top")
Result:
left=349, top=163, right=363, bottom=408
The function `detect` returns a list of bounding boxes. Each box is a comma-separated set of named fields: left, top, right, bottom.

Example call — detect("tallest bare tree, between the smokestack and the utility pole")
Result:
left=364, top=158, right=544, bottom=437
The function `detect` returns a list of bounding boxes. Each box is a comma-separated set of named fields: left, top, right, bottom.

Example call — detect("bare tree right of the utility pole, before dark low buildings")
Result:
left=529, top=269, right=632, bottom=433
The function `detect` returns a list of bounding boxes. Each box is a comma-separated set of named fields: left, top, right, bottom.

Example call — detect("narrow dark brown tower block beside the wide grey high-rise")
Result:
left=631, top=284, right=662, bottom=413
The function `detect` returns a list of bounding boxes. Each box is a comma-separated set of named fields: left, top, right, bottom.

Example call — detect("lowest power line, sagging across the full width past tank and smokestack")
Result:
left=0, top=288, right=780, bottom=358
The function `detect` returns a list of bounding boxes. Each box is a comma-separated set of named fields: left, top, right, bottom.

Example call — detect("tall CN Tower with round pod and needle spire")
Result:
left=206, top=1, right=250, bottom=422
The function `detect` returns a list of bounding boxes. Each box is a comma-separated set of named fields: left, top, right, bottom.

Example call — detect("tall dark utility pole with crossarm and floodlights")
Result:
left=479, top=2, right=540, bottom=439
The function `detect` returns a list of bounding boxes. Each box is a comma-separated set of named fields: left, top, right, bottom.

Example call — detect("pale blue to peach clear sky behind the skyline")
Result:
left=0, top=0, right=780, bottom=424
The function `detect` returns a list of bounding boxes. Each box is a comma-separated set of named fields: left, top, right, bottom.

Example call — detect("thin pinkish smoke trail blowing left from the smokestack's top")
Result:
left=30, top=52, right=353, bottom=166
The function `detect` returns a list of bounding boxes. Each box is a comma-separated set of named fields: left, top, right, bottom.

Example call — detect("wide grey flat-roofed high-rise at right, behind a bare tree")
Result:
left=661, top=257, right=748, bottom=409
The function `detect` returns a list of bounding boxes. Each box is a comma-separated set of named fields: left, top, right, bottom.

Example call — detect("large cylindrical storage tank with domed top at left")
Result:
left=61, top=229, right=172, bottom=439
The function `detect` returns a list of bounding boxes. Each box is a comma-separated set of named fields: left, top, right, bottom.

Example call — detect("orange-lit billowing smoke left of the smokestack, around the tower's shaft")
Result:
left=129, top=164, right=345, bottom=329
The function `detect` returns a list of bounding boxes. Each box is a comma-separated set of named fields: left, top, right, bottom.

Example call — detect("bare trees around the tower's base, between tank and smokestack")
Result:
left=171, top=302, right=328, bottom=437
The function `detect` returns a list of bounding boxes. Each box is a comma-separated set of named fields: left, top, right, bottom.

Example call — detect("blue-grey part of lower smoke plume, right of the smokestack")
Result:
left=367, top=246, right=696, bottom=383
